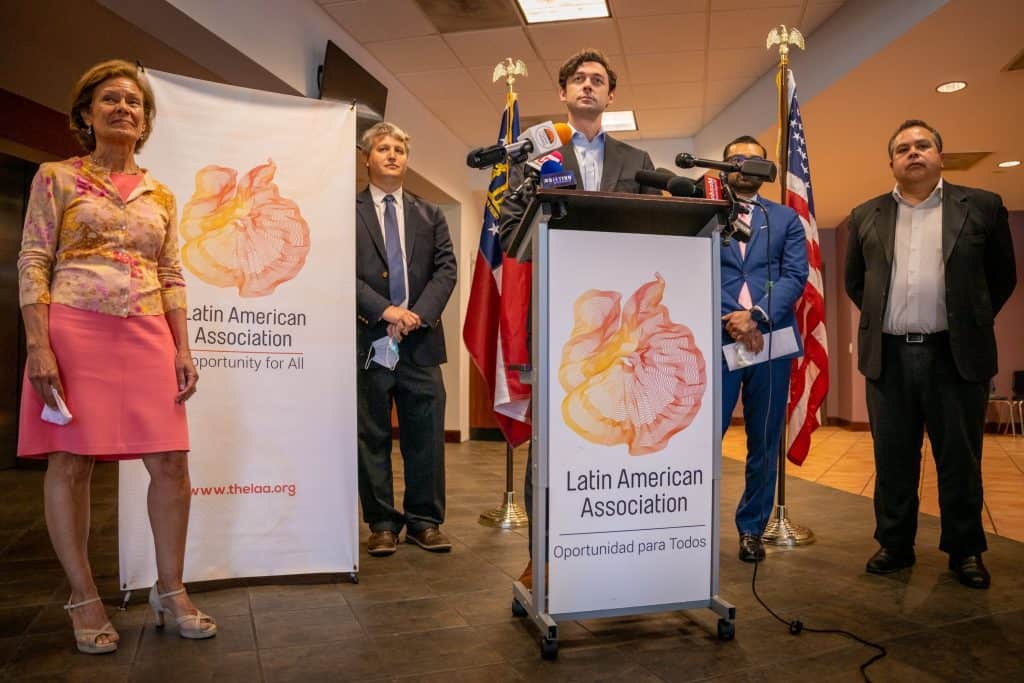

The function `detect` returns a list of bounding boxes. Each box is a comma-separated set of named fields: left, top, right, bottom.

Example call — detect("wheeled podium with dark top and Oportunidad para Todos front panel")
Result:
left=510, top=190, right=736, bottom=659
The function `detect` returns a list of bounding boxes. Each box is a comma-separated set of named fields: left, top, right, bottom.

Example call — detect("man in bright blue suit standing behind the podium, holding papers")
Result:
left=722, top=135, right=807, bottom=562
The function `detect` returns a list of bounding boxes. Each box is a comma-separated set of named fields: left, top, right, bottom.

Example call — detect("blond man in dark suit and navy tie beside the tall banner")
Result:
left=355, top=122, right=456, bottom=556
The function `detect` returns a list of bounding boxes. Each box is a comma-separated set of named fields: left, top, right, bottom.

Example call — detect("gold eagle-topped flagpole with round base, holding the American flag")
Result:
left=761, top=25, right=814, bottom=547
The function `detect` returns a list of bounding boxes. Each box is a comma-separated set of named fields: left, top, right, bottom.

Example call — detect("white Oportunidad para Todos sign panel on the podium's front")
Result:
left=548, top=229, right=721, bottom=614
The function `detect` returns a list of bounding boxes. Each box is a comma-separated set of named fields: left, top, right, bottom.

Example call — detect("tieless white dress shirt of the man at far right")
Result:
left=882, top=178, right=949, bottom=335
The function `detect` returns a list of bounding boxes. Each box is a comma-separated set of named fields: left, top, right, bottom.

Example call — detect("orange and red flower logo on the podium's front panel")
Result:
left=558, top=273, right=707, bottom=456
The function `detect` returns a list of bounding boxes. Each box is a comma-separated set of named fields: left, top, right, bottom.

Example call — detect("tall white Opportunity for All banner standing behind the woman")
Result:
left=118, top=71, right=358, bottom=590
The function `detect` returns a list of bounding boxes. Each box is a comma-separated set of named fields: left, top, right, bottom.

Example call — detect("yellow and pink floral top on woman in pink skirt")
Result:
left=17, top=157, right=185, bottom=317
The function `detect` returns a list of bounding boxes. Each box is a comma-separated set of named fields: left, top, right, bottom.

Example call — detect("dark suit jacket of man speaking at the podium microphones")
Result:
left=498, top=134, right=662, bottom=251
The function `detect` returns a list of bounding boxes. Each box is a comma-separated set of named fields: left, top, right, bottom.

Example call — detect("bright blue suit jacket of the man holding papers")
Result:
left=722, top=196, right=807, bottom=358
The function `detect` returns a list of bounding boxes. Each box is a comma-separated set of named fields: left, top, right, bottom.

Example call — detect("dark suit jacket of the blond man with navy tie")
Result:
left=355, top=187, right=457, bottom=366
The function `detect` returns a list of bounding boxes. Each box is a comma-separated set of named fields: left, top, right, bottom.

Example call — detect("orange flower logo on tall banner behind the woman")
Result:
left=180, top=160, right=309, bottom=297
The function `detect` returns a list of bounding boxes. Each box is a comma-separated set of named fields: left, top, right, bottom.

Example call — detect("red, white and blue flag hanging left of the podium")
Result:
left=462, top=92, right=530, bottom=445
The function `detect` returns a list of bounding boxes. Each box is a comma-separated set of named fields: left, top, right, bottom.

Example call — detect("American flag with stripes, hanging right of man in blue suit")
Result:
left=783, top=71, right=828, bottom=465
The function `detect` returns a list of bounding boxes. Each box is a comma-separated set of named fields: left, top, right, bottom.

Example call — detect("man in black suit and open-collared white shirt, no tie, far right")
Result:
left=846, top=120, right=1017, bottom=588
